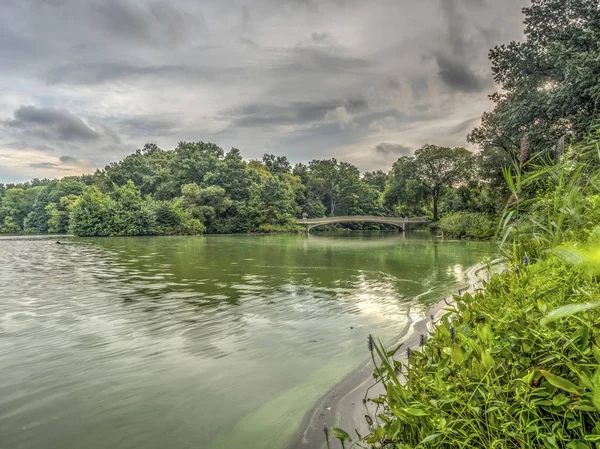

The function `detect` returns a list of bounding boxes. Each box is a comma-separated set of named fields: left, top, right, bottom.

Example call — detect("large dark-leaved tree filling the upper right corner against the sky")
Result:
left=469, top=0, right=600, bottom=153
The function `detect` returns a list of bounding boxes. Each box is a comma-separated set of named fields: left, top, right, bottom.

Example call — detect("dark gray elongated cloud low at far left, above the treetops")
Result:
left=3, top=106, right=100, bottom=142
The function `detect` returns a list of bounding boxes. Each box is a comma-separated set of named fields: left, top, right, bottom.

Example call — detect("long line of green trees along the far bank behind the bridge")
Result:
left=0, top=142, right=493, bottom=236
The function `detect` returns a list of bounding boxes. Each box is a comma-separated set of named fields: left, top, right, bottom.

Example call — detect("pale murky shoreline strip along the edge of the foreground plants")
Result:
left=286, top=258, right=504, bottom=449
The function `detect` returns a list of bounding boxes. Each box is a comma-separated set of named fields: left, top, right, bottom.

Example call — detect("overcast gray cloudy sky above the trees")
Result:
left=0, top=0, right=527, bottom=182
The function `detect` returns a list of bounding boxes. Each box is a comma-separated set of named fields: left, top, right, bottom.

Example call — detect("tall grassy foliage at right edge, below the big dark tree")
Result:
left=502, top=140, right=600, bottom=259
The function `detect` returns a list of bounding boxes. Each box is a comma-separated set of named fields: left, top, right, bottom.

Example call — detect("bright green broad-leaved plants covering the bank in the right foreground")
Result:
left=366, top=250, right=600, bottom=449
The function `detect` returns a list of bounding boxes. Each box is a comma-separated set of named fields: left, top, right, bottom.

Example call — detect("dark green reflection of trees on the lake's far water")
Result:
left=82, top=234, right=492, bottom=330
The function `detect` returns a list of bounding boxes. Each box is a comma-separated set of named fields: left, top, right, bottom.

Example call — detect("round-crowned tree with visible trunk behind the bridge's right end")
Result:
left=413, top=145, right=475, bottom=221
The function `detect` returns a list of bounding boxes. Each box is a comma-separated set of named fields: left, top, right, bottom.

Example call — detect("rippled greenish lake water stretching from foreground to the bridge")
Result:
left=0, top=233, right=493, bottom=449
